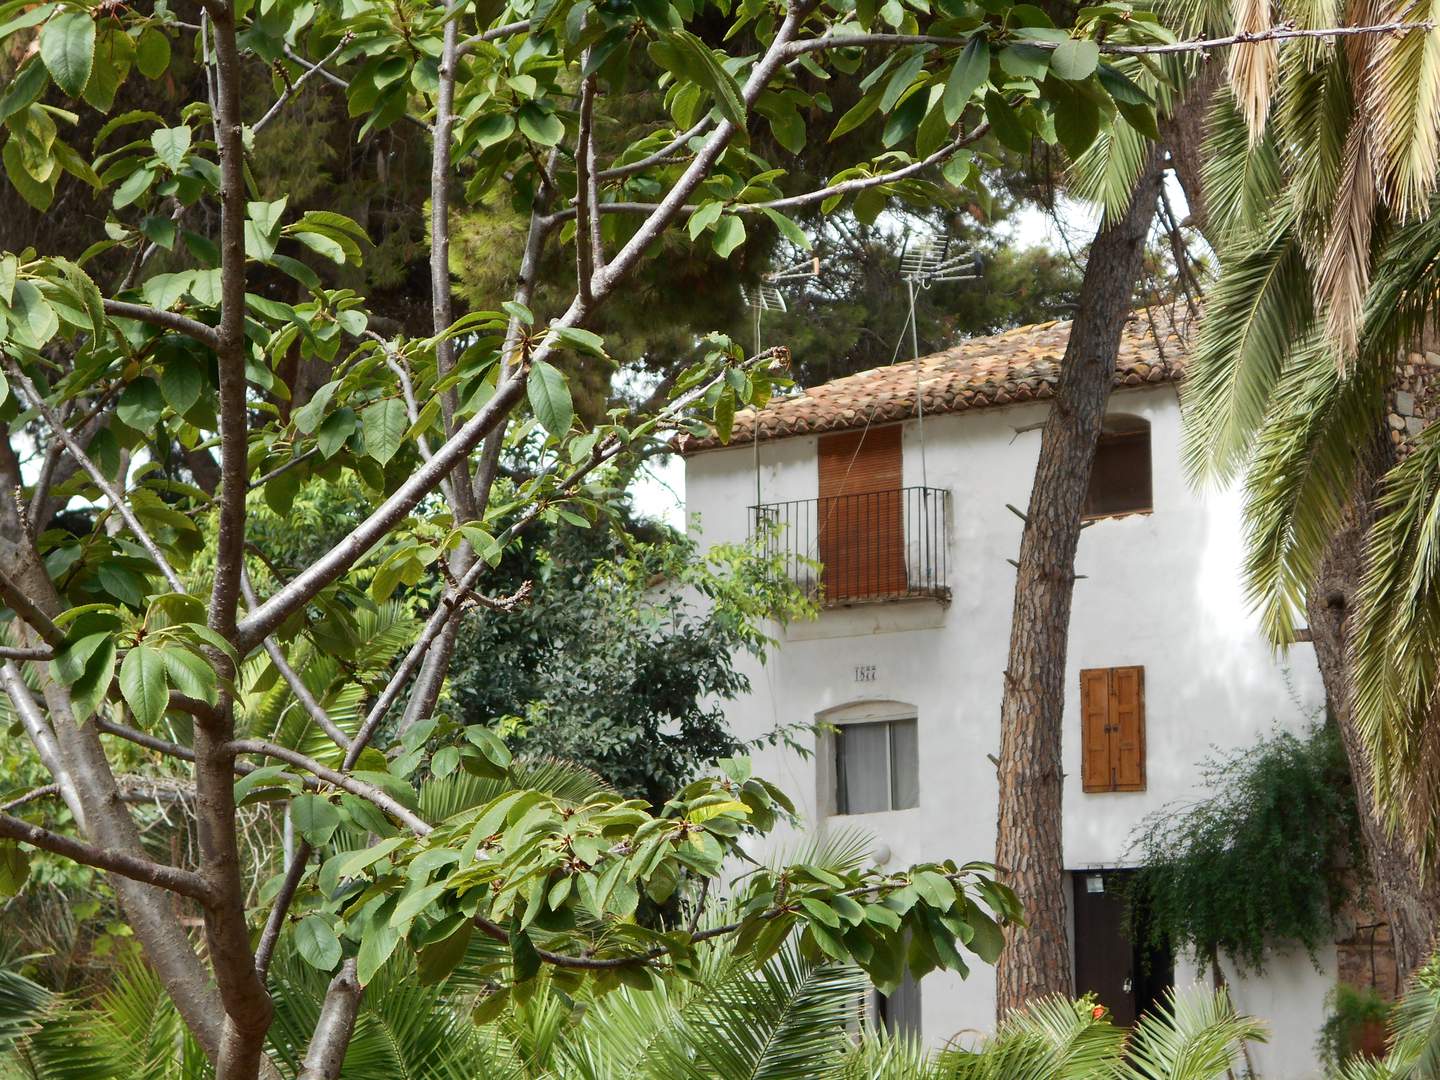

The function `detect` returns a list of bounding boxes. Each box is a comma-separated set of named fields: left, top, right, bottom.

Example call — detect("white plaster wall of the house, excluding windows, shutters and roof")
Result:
left=685, top=386, right=1333, bottom=1080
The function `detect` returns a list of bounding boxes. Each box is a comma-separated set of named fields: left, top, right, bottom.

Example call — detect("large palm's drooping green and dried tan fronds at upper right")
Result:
left=1117, top=0, right=1440, bottom=972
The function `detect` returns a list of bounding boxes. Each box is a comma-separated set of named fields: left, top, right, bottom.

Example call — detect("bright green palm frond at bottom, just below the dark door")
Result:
left=1120, top=988, right=1266, bottom=1080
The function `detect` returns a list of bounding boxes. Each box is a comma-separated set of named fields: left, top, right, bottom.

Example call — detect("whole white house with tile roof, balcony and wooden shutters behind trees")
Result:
left=685, top=308, right=1335, bottom=1080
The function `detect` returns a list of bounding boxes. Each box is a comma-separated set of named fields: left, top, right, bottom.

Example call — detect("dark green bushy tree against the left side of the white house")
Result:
left=449, top=526, right=809, bottom=805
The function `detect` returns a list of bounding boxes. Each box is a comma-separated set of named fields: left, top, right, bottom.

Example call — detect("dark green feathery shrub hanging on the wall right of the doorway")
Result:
left=1128, top=724, right=1362, bottom=969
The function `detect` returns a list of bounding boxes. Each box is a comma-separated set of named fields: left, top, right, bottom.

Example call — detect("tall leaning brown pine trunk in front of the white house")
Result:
left=995, top=151, right=1161, bottom=1018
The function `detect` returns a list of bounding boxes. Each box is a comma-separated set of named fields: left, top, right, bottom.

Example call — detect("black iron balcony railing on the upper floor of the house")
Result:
left=750, top=488, right=950, bottom=606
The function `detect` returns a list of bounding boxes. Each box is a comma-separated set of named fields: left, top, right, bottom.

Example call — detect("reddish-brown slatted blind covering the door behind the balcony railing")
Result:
left=816, top=425, right=906, bottom=602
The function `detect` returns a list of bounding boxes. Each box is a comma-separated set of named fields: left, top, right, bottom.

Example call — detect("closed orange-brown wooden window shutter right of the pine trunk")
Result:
left=1080, top=667, right=1145, bottom=792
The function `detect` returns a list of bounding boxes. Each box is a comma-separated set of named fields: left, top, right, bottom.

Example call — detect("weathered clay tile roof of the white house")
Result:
left=681, top=308, right=1187, bottom=454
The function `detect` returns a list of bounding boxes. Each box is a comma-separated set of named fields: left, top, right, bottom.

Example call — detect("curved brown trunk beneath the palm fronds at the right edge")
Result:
left=1306, top=435, right=1440, bottom=984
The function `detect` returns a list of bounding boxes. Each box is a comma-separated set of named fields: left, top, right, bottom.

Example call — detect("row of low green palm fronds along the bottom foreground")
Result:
left=0, top=946, right=1263, bottom=1080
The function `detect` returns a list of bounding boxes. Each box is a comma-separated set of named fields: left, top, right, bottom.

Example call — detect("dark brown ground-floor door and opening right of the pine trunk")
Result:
left=1073, top=870, right=1175, bottom=1027
